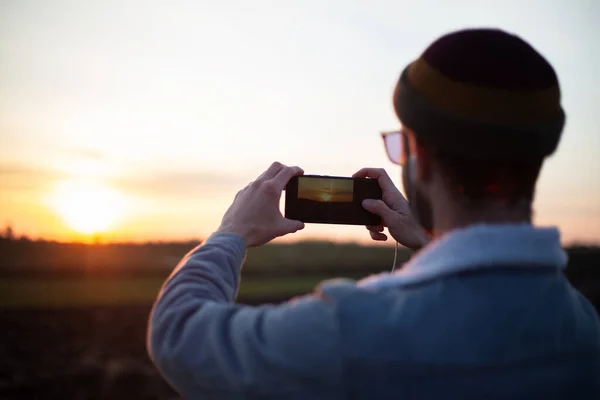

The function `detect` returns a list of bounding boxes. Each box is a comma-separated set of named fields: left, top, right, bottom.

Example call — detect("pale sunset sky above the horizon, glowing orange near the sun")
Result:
left=0, top=0, right=600, bottom=243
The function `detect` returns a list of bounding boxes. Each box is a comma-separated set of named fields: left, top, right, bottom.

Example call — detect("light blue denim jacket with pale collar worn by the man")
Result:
left=148, top=225, right=600, bottom=399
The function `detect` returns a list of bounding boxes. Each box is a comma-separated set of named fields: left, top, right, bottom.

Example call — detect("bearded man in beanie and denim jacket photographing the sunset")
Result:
left=149, top=29, right=600, bottom=399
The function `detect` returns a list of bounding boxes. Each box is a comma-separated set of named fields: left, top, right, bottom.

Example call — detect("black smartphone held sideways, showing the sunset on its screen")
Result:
left=285, top=175, right=381, bottom=225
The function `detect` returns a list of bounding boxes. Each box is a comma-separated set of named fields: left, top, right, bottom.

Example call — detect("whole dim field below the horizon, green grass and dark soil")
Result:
left=0, top=240, right=600, bottom=400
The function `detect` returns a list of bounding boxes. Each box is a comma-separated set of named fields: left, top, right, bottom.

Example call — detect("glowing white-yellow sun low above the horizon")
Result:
left=52, top=180, right=125, bottom=235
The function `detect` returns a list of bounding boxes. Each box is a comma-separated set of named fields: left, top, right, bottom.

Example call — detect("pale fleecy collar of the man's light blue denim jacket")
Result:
left=358, top=224, right=567, bottom=288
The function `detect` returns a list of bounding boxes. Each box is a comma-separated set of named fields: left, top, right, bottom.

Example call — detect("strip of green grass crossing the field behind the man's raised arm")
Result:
left=0, top=276, right=323, bottom=308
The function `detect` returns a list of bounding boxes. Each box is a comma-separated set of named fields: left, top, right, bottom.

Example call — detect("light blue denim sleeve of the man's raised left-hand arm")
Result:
left=148, top=234, right=342, bottom=398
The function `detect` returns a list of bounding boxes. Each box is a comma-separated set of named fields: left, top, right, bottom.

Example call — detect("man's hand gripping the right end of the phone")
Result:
left=353, top=168, right=431, bottom=250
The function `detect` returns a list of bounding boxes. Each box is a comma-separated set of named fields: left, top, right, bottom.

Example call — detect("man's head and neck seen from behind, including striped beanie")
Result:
left=394, top=29, right=565, bottom=231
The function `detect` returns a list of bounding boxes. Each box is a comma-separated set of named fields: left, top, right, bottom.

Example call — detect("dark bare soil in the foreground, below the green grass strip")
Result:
left=0, top=299, right=283, bottom=400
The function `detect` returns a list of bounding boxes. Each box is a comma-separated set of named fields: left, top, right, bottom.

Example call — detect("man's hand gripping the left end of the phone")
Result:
left=217, top=162, right=304, bottom=247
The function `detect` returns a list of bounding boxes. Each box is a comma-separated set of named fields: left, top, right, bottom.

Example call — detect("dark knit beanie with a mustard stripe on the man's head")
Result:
left=393, top=29, right=565, bottom=161
